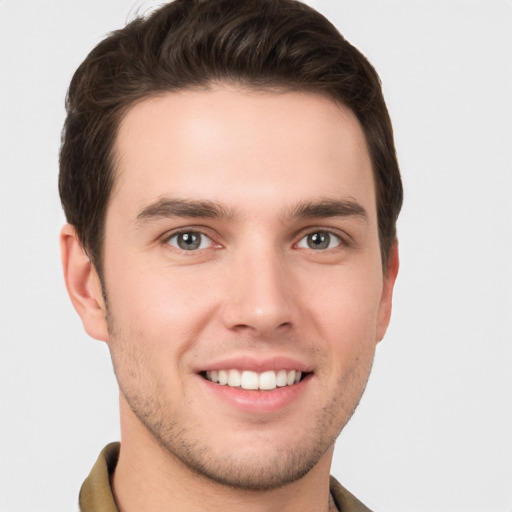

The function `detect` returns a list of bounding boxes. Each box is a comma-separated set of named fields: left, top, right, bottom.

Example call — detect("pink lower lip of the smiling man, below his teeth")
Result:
left=200, top=374, right=312, bottom=414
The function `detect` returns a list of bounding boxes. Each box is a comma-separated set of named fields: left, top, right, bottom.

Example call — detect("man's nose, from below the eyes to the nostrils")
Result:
left=222, top=250, right=296, bottom=338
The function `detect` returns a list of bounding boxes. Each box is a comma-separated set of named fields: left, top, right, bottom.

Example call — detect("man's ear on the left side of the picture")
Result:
left=60, top=224, right=108, bottom=341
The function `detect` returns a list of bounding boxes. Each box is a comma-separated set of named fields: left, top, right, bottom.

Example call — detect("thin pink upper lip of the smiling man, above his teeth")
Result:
left=196, top=356, right=313, bottom=373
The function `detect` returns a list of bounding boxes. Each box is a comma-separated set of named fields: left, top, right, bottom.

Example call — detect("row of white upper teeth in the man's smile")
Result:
left=206, top=369, right=302, bottom=391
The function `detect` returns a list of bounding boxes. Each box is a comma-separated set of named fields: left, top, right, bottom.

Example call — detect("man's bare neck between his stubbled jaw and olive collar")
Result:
left=112, top=400, right=336, bottom=512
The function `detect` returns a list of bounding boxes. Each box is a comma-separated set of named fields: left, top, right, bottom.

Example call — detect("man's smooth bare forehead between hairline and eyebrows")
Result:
left=111, top=86, right=375, bottom=220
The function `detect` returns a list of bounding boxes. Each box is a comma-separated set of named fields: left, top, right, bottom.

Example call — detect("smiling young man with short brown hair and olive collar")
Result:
left=59, top=0, right=402, bottom=512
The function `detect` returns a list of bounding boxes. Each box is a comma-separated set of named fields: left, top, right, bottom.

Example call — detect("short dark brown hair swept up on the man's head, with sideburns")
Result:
left=59, top=0, right=403, bottom=277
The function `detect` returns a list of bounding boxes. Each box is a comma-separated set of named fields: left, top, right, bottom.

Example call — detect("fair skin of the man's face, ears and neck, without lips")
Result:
left=61, top=85, right=398, bottom=512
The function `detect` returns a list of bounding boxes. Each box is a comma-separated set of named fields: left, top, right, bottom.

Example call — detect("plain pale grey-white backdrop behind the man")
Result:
left=0, top=0, right=512, bottom=512
